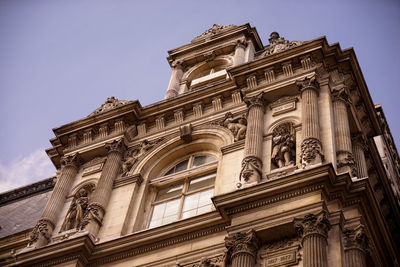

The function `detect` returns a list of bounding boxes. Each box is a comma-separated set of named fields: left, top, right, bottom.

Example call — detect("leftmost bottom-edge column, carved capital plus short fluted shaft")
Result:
left=225, top=230, right=259, bottom=267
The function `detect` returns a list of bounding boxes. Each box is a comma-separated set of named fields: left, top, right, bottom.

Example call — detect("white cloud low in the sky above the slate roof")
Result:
left=0, top=149, right=56, bottom=192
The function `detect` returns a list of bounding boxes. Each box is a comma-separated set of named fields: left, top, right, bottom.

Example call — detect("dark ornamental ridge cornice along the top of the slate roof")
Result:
left=0, top=176, right=55, bottom=206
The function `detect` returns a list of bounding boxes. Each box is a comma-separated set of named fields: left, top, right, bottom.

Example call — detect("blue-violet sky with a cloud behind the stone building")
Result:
left=0, top=0, right=400, bottom=192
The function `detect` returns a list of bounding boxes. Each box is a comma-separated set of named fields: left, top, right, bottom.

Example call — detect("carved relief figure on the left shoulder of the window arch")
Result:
left=121, top=138, right=163, bottom=176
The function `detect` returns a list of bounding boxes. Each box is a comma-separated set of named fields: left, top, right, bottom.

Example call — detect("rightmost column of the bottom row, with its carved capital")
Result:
left=344, top=225, right=368, bottom=267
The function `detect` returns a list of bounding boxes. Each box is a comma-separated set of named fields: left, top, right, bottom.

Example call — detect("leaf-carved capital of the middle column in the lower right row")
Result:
left=294, top=210, right=331, bottom=238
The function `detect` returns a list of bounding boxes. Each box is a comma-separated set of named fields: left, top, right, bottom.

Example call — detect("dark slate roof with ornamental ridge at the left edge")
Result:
left=0, top=177, right=54, bottom=238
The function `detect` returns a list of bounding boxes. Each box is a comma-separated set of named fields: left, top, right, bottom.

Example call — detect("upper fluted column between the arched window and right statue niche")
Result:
left=240, top=93, right=264, bottom=183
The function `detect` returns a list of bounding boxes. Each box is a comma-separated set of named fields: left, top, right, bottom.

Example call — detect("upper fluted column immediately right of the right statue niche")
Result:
left=296, top=75, right=324, bottom=167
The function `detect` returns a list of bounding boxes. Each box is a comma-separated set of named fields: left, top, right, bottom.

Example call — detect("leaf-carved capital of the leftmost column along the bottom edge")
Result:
left=225, top=230, right=259, bottom=258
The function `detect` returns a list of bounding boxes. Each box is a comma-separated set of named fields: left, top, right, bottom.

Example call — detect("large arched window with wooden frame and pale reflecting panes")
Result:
left=148, top=154, right=217, bottom=228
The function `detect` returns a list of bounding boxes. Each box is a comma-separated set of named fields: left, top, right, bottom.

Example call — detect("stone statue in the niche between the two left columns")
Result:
left=61, top=188, right=89, bottom=232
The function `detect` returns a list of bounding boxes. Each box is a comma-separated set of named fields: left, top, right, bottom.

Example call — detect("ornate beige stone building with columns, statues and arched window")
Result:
left=0, top=24, right=400, bottom=267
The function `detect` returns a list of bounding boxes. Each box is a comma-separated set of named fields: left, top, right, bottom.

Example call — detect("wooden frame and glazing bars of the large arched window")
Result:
left=145, top=156, right=218, bottom=229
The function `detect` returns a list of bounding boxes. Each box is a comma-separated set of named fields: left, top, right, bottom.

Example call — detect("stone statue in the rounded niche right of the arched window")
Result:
left=271, top=123, right=296, bottom=168
